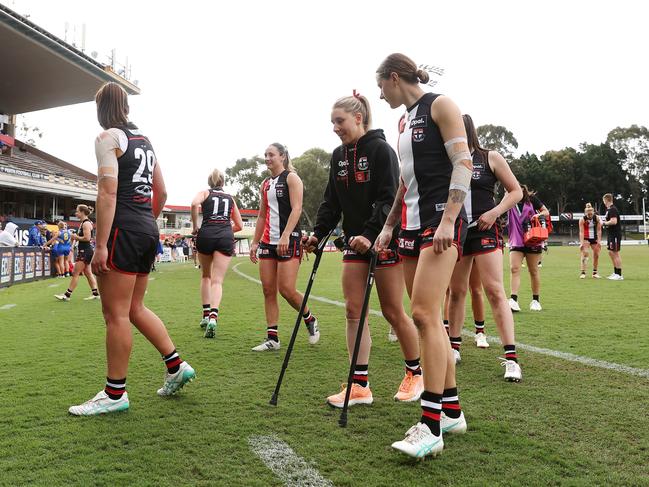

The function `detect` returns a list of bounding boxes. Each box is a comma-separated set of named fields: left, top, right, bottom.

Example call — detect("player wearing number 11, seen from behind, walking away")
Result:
left=192, top=169, right=243, bottom=338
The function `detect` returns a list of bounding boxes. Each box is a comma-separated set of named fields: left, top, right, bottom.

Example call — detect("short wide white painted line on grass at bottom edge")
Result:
left=248, top=436, right=334, bottom=487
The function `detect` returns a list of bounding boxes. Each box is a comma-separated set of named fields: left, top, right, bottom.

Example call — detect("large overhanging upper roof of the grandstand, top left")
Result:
left=0, top=4, right=140, bottom=115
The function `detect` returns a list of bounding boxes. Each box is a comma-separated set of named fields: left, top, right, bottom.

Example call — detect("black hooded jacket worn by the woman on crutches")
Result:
left=314, top=129, right=399, bottom=243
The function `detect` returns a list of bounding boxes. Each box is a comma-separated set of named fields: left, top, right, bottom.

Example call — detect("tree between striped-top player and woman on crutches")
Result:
left=292, top=148, right=331, bottom=229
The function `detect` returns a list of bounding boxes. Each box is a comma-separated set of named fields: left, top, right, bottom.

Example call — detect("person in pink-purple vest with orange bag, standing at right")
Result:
left=507, top=184, right=550, bottom=311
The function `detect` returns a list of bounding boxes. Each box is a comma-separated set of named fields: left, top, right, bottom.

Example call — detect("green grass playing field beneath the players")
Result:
left=0, top=247, right=649, bottom=486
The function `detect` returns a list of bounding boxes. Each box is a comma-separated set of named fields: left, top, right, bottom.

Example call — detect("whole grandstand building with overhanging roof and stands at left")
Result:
left=0, top=4, right=140, bottom=285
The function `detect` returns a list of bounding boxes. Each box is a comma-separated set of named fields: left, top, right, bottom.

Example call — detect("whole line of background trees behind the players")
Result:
left=225, top=125, right=649, bottom=223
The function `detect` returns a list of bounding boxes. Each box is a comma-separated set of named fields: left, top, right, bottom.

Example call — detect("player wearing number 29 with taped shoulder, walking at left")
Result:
left=69, top=83, right=196, bottom=416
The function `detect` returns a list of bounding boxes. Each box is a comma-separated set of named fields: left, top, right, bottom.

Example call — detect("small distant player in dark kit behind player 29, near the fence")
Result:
left=54, top=205, right=99, bottom=301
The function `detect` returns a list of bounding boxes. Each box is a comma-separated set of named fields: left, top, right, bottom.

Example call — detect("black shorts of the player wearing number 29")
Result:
left=108, top=228, right=158, bottom=276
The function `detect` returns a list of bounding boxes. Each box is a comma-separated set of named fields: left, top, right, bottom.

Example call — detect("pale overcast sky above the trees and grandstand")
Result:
left=6, top=0, right=649, bottom=204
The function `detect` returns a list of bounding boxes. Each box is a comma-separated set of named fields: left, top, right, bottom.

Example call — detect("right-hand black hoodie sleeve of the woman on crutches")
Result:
left=362, top=142, right=399, bottom=243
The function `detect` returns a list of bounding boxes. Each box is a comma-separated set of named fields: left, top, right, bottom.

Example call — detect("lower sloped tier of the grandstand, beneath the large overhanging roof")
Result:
left=0, top=140, right=97, bottom=200
